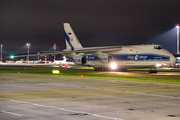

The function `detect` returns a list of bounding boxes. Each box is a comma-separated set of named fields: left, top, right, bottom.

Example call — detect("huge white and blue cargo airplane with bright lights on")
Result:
left=13, top=23, right=176, bottom=73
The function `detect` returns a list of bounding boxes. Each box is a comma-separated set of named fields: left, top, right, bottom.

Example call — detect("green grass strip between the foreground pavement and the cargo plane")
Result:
left=0, top=68, right=180, bottom=84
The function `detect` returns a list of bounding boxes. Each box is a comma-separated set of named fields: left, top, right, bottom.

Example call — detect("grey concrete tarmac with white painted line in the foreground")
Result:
left=0, top=73, right=180, bottom=120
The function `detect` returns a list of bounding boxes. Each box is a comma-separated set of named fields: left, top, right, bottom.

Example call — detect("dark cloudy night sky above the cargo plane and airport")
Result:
left=0, top=0, right=180, bottom=53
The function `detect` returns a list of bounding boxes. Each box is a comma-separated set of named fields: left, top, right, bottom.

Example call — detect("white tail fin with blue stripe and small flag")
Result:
left=63, top=23, right=82, bottom=51
